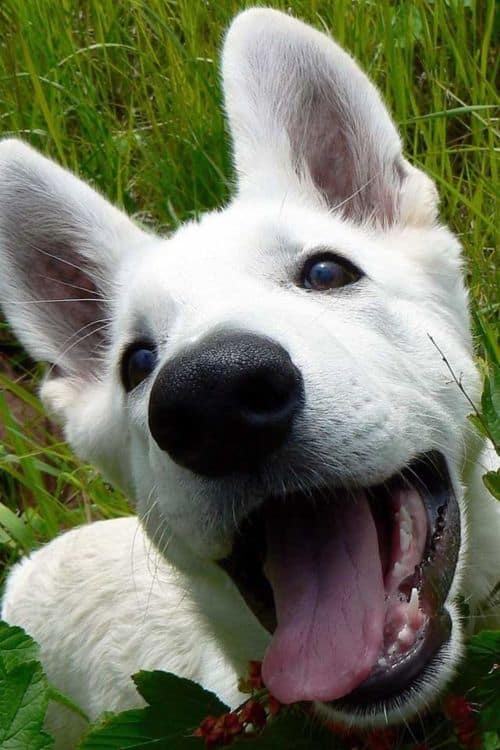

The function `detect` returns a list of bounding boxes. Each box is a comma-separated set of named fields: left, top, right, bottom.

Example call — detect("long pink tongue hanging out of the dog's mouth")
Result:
left=262, top=492, right=385, bottom=703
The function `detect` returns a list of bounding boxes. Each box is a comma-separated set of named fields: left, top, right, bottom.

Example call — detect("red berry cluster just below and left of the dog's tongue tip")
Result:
left=194, top=661, right=281, bottom=748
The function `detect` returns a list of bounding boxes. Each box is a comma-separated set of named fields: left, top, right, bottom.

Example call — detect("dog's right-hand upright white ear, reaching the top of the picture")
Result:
left=223, top=8, right=437, bottom=224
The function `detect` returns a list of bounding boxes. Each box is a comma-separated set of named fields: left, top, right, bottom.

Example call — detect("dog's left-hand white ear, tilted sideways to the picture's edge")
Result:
left=0, top=140, right=143, bottom=376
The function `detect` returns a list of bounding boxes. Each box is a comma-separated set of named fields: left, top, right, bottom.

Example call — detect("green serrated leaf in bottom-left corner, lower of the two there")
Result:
left=0, top=661, right=54, bottom=750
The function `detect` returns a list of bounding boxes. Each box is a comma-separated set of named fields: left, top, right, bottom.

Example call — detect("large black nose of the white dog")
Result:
left=149, top=331, right=303, bottom=477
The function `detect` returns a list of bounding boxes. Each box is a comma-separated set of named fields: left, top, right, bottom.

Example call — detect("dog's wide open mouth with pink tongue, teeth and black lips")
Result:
left=219, top=452, right=460, bottom=707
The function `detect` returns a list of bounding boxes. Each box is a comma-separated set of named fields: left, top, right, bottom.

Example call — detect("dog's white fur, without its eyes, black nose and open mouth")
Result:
left=0, top=9, right=500, bottom=748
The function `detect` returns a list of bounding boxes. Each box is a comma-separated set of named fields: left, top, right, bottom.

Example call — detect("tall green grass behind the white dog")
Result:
left=0, top=0, right=498, bottom=581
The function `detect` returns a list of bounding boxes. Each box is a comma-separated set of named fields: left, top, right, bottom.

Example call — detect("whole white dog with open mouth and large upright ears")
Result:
left=0, top=9, right=500, bottom=748
